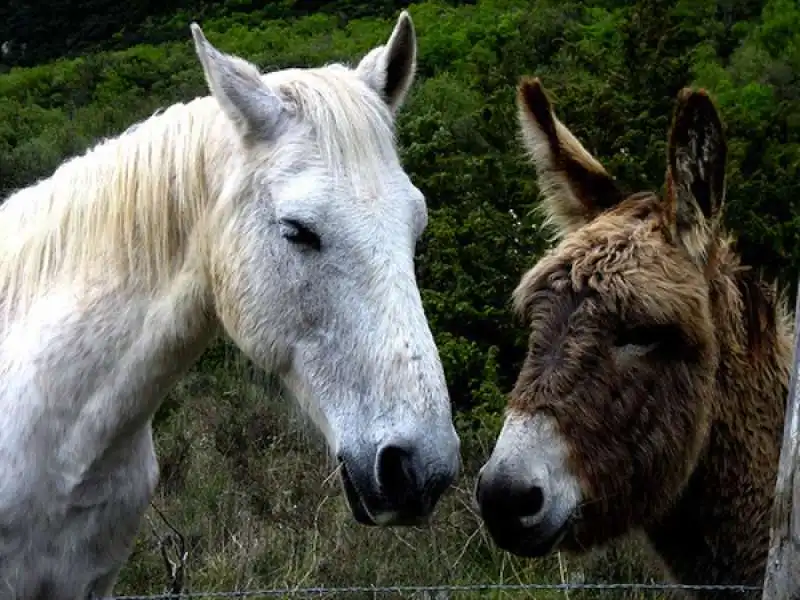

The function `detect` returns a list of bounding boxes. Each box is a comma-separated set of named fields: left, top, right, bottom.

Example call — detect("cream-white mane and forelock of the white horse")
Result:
left=0, top=65, right=397, bottom=322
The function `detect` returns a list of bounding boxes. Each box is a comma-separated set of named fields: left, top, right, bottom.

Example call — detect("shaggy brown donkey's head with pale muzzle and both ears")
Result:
left=476, top=79, right=726, bottom=556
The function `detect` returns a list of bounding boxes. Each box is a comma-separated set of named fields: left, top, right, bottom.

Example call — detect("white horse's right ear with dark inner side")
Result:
left=356, top=10, right=417, bottom=112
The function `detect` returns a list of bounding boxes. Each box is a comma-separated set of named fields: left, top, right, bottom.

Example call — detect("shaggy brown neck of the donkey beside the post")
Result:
left=648, top=247, right=792, bottom=598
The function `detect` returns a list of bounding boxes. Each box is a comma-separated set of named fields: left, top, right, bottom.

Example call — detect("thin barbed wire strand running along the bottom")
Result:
left=102, top=583, right=762, bottom=600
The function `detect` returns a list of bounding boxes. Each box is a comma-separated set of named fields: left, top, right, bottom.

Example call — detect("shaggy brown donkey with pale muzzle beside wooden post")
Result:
left=476, top=79, right=792, bottom=598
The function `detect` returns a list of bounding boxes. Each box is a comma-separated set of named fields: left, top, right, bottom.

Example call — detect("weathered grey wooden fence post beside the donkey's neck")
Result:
left=762, top=282, right=800, bottom=600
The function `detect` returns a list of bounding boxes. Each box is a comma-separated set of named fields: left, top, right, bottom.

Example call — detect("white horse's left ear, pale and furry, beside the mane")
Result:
left=191, top=23, right=286, bottom=139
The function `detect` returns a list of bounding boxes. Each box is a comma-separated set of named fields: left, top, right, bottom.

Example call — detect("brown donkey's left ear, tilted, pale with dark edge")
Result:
left=517, top=78, right=622, bottom=235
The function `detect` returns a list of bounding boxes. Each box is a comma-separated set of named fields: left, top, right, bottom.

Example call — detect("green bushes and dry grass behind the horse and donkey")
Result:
left=0, top=0, right=800, bottom=598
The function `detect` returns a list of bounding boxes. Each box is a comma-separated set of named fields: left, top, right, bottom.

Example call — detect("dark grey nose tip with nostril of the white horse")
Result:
left=375, top=440, right=458, bottom=523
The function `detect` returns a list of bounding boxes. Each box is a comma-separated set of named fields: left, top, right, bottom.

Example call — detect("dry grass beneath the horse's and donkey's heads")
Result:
left=115, top=342, right=660, bottom=600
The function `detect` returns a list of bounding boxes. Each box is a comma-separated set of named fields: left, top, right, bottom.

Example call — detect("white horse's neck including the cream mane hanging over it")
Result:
left=0, top=101, right=226, bottom=454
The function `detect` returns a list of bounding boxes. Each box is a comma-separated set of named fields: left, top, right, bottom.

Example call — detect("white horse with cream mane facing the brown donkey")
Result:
left=0, top=12, right=459, bottom=600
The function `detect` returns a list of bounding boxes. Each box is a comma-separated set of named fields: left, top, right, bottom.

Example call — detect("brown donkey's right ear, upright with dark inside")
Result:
left=666, top=88, right=727, bottom=258
